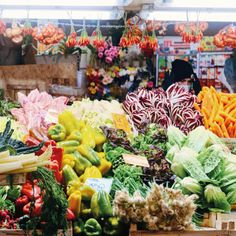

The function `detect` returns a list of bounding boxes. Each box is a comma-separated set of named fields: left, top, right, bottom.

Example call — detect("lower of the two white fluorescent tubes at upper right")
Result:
left=141, top=10, right=236, bottom=22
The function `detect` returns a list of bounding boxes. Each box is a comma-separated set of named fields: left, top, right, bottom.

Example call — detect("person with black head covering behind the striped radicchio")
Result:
left=162, top=59, right=201, bottom=95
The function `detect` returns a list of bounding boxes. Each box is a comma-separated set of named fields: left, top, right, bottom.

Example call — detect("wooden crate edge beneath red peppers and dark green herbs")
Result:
left=0, top=224, right=73, bottom=236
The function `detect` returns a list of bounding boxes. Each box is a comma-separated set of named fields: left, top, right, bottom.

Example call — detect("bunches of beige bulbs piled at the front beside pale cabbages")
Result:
left=114, top=184, right=196, bottom=231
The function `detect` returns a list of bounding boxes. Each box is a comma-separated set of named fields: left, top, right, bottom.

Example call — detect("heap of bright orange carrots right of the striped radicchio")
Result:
left=195, top=87, right=236, bottom=138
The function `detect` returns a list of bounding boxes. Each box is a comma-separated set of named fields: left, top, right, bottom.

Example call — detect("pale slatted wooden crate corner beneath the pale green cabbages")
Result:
left=202, top=212, right=236, bottom=230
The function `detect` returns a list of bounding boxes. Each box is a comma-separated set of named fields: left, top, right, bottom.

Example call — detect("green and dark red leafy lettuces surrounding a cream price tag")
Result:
left=102, top=124, right=172, bottom=196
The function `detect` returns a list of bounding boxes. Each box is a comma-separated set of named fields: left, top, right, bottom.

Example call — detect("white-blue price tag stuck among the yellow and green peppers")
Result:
left=84, top=178, right=113, bottom=193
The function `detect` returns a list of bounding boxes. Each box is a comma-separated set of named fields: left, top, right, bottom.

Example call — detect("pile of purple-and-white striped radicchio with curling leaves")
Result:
left=123, top=84, right=202, bottom=133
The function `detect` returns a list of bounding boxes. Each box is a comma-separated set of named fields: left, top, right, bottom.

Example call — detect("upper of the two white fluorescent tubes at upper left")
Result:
left=0, top=0, right=131, bottom=8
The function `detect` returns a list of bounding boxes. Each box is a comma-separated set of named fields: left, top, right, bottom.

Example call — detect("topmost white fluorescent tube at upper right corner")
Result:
left=167, top=0, right=236, bottom=9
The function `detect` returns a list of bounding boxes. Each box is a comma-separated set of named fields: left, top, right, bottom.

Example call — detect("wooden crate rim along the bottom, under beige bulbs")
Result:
left=130, top=225, right=229, bottom=236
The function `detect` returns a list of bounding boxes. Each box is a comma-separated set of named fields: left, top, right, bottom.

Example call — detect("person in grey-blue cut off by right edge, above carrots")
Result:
left=224, top=49, right=236, bottom=93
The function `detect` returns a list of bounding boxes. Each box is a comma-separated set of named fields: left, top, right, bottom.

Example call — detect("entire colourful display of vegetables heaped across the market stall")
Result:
left=0, top=85, right=236, bottom=236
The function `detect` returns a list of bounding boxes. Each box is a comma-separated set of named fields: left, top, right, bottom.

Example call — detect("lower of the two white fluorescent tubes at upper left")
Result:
left=1, top=9, right=123, bottom=20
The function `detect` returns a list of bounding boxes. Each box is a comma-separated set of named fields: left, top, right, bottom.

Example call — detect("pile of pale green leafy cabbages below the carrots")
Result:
left=167, top=126, right=236, bottom=212
